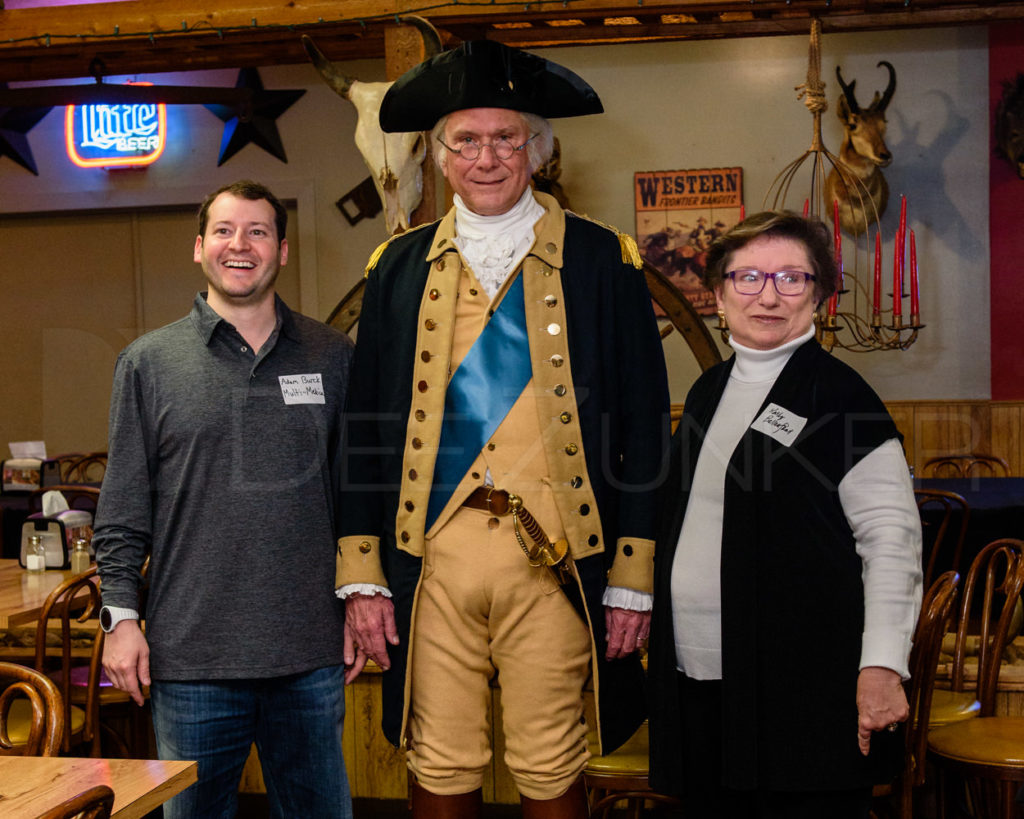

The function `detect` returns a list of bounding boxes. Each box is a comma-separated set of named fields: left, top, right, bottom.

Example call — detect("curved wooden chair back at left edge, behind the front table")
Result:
left=0, top=661, right=65, bottom=757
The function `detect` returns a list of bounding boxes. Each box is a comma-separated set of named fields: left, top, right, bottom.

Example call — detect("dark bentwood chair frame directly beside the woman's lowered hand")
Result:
left=872, top=571, right=959, bottom=819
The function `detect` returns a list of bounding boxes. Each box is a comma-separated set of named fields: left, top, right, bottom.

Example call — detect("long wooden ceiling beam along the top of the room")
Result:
left=0, top=0, right=1024, bottom=82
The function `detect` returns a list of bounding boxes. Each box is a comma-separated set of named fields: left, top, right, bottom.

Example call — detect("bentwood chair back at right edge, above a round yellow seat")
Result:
left=950, top=537, right=1024, bottom=717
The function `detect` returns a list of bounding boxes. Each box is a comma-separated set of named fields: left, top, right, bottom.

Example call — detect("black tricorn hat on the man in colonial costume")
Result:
left=380, top=40, right=604, bottom=132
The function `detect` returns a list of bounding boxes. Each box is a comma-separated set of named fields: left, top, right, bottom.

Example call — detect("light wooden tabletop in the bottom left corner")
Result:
left=0, top=757, right=197, bottom=819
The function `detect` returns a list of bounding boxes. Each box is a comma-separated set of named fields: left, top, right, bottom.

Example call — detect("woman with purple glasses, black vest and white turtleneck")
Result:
left=649, top=212, right=921, bottom=819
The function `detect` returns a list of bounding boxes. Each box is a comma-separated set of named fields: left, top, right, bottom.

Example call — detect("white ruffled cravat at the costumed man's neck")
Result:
left=455, top=187, right=545, bottom=298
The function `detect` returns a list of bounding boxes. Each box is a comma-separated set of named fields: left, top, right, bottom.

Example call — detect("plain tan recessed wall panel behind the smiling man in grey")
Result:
left=0, top=202, right=300, bottom=457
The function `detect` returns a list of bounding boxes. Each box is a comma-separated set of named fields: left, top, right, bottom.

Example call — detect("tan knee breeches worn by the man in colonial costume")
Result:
left=408, top=508, right=591, bottom=800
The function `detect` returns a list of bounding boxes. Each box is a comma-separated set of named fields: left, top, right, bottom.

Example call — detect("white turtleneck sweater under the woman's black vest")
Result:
left=672, top=328, right=921, bottom=680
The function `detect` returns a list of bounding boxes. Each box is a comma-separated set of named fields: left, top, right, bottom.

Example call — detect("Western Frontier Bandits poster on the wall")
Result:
left=633, top=168, right=743, bottom=316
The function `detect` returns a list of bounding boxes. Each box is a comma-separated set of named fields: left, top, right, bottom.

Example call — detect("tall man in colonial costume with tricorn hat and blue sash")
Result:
left=337, top=42, right=668, bottom=819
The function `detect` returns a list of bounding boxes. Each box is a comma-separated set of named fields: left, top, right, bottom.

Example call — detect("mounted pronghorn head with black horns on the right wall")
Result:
left=825, top=60, right=896, bottom=235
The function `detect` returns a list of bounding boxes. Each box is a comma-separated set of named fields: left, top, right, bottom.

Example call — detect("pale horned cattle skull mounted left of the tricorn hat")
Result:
left=302, top=16, right=441, bottom=233
